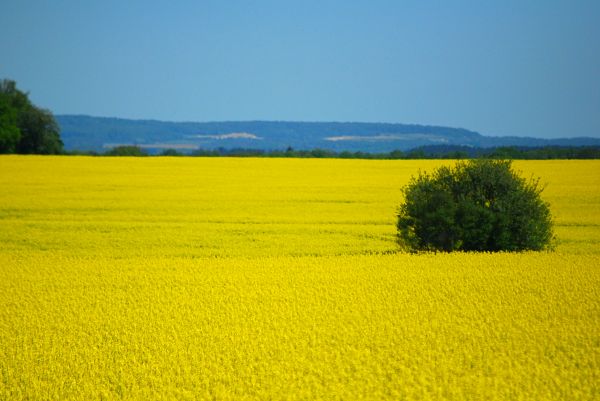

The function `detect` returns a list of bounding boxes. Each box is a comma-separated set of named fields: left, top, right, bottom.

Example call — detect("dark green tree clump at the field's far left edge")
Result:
left=0, top=79, right=63, bottom=154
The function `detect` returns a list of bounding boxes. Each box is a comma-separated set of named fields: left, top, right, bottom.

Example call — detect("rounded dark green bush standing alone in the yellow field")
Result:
left=397, top=160, right=553, bottom=252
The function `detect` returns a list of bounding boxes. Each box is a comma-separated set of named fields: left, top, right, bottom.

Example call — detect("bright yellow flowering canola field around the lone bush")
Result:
left=0, top=156, right=600, bottom=400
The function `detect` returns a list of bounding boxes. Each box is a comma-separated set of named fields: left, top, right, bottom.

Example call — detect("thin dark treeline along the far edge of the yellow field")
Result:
left=70, top=146, right=600, bottom=160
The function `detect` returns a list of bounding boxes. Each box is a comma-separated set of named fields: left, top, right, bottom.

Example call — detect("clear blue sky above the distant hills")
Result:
left=0, top=0, right=600, bottom=137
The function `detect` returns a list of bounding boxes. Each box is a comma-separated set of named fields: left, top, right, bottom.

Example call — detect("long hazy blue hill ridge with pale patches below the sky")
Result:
left=55, top=115, right=600, bottom=152
